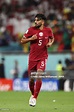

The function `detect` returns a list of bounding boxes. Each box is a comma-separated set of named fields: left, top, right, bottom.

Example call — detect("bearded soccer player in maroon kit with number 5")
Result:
left=21, top=13, right=54, bottom=106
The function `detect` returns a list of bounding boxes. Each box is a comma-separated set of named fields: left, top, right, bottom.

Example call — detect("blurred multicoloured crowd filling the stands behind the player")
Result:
left=0, top=0, right=74, bottom=53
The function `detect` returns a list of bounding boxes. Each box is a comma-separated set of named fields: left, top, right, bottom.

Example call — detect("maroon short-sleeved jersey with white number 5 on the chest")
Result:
left=24, top=27, right=53, bottom=61
